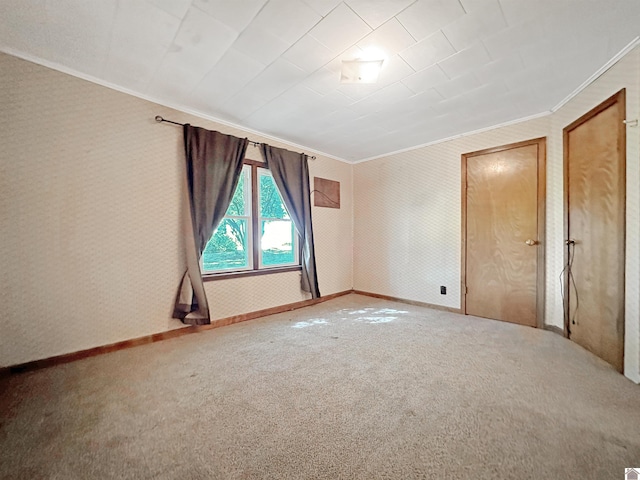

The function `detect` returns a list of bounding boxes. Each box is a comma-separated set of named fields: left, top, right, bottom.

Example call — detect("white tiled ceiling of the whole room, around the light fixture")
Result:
left=0, top=0, right=640, bottom=161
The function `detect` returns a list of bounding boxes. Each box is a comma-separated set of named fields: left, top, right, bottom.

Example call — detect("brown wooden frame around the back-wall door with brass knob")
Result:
left=460, top=137, right=547, bottom=328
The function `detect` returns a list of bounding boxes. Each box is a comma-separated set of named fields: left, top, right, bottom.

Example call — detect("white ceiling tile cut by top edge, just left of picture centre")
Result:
left=249, top=0, right=322, bottom=44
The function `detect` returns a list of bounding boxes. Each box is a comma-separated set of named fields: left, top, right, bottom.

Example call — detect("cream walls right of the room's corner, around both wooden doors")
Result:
left=354, top=48, right=640, bottom=382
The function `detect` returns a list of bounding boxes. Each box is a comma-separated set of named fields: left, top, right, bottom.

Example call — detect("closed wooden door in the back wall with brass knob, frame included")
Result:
left=462, top=138, right=545, bottom=327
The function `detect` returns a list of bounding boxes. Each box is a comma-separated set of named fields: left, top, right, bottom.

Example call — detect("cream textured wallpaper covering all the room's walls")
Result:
left=0, top=49, right=640, bottom=381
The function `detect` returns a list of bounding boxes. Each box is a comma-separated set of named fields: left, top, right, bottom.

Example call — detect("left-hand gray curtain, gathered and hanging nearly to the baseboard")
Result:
left=173, top=124, right=248, bottom=325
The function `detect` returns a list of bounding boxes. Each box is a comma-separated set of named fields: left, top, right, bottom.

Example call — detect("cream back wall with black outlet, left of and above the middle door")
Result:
left=354, top=117, right=549, bottom=308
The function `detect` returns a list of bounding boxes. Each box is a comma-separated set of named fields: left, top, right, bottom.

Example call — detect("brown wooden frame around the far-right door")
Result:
left=562, top=88, right=627, bottom=340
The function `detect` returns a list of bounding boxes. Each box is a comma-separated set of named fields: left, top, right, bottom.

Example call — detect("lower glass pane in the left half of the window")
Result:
left=202, top=218, right=250, bottom=272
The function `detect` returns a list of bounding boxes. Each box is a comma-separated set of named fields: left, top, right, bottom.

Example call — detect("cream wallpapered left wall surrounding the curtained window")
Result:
left=0, top=54, right=353, bottom=366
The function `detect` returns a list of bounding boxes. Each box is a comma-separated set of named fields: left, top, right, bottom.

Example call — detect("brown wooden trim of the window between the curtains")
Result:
left=201, top=158, right=302, bottom=282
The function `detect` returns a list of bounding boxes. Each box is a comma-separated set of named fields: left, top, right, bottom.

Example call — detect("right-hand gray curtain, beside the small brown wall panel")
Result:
left=260, top=143, right=320, bottom=298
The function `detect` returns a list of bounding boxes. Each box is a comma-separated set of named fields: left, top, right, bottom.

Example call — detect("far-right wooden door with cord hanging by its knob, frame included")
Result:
left=564, top=90, right=626, bottom=372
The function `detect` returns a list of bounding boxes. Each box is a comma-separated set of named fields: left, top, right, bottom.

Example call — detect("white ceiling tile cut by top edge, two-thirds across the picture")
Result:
left=397, top=0, right=465, bottom=40
